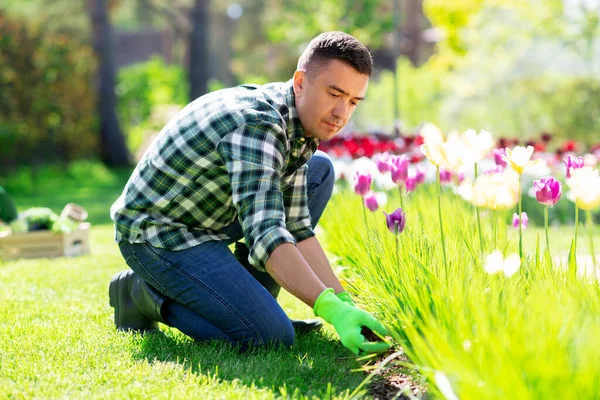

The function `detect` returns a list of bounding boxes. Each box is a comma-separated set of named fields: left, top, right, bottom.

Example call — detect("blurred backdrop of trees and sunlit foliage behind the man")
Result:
left=0, top=0, right=600, bottom=173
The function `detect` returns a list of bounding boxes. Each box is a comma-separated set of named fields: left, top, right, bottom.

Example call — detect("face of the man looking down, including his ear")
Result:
left=294, top=60, right=369, bottom=140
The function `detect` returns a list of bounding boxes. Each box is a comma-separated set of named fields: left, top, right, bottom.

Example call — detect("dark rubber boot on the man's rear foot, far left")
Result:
left=108, top=270, right=165, bottom=331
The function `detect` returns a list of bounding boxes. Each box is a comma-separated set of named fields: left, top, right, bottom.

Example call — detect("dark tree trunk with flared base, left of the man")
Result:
left=88, top=0, right=131, bottom=166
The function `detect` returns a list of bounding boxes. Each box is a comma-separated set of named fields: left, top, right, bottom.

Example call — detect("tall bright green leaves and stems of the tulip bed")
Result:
left=322, top=187, right=600, bottom=399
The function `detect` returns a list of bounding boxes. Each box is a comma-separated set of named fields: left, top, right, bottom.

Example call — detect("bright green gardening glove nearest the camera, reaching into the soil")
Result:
left=313, top=288, right=390, bottom=354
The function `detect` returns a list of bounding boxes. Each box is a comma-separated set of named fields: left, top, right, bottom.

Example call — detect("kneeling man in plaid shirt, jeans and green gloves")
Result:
left=109, top=32, right=389, bottom=354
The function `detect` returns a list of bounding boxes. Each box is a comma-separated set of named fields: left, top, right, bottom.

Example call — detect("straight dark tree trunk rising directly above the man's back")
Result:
left=188, top=0, right=210, bottom=101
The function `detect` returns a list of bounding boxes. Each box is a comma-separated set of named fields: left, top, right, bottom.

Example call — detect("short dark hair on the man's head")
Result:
left=297, top=31, right=373, bottom=78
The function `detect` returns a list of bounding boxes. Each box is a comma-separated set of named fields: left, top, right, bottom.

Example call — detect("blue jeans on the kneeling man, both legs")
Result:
left=119, top=151, right=335, bottom=348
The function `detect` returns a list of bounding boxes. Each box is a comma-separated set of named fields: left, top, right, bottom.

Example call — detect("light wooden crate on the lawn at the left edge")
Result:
left=0, top=222, right=90, bottom=260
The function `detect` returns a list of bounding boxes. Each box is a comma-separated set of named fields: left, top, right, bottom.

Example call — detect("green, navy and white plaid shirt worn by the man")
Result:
left=110, top=81, right=319, bottom=270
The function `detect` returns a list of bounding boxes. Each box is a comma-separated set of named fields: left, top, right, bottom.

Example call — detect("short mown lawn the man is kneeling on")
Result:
left=0, top=165, right=365, bottom=399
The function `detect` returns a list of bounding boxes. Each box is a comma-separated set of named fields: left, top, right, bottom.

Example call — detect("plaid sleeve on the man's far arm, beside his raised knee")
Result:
left=283, top=164, right=315, bottom=242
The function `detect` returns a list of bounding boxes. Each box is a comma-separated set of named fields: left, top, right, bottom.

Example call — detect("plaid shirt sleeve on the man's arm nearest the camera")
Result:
left=218, top=120, right=296, bottom=271
